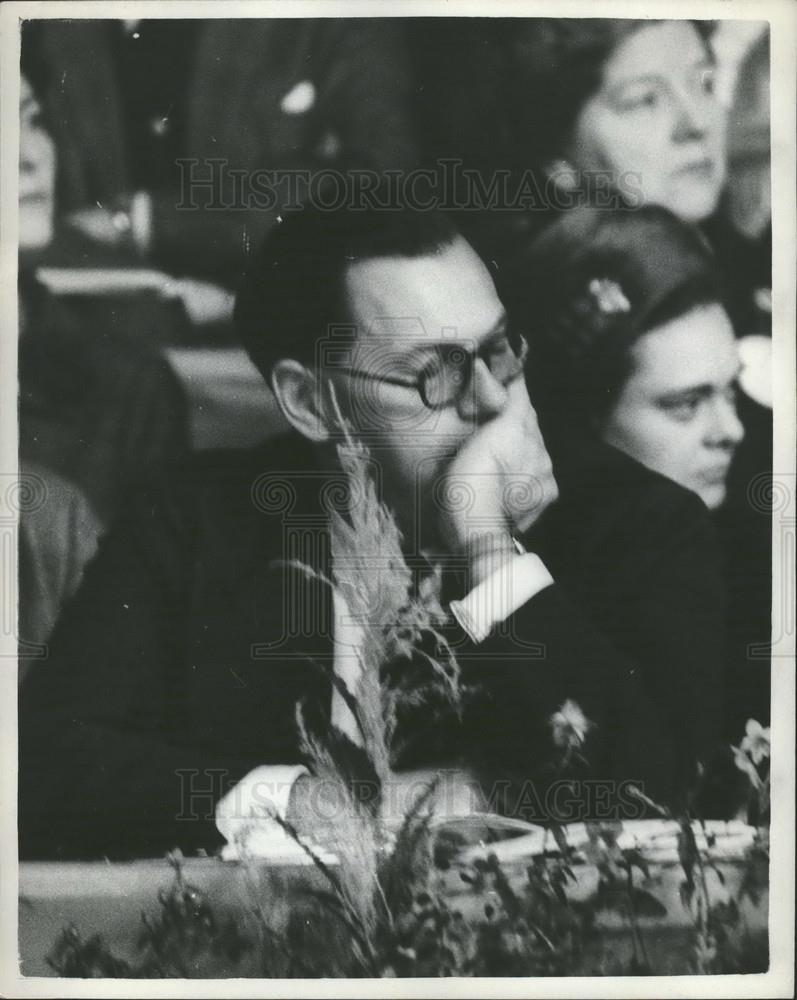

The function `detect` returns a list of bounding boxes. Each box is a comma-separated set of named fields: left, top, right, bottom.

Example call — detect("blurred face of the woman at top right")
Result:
left=566, top=21, right=726, bottom=222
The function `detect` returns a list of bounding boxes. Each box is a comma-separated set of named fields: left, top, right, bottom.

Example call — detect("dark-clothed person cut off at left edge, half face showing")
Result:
left=19, top=77, right=188, bottom=540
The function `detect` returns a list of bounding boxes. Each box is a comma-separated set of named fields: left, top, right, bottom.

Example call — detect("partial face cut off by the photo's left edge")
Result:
left=19, top=76, right=55, bottom=251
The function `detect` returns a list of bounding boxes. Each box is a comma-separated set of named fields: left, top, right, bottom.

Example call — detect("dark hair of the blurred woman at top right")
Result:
left=504, top=17, right=714, bottom=167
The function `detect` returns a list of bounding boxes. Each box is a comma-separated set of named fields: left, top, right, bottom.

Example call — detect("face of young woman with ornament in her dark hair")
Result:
left=603, top=304, right=744, bottom=510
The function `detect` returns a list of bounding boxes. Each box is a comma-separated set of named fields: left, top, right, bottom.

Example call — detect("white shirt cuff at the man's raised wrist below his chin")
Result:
left=451, top=552, right=553, bottom=643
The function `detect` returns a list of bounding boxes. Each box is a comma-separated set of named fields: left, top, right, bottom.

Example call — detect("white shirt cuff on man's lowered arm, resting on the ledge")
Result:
left=216, top=764, right=309, bottom=858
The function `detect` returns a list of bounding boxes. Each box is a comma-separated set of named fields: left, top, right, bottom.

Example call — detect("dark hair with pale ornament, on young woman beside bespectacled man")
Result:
left=498, top=206, right=722, bottom=439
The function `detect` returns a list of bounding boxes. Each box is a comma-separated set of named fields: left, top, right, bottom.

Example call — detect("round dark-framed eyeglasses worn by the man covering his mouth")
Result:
left=338, top=331, right=529, bottom=410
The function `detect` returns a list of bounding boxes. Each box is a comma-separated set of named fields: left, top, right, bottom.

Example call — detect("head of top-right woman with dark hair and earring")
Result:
left=508, top=18, right=727, bottom=223
